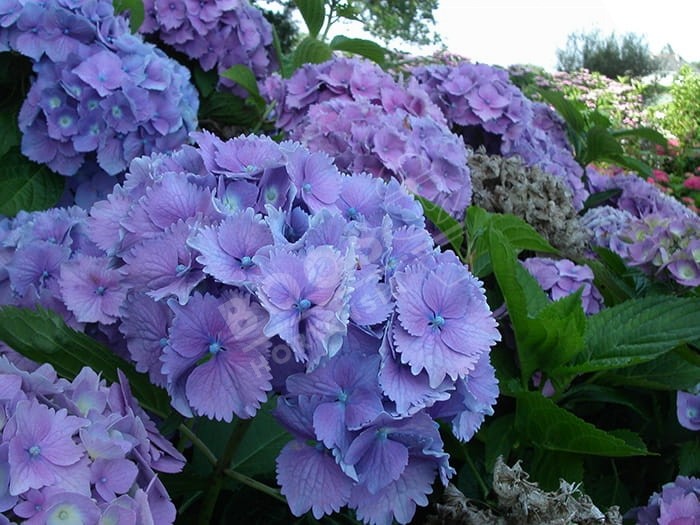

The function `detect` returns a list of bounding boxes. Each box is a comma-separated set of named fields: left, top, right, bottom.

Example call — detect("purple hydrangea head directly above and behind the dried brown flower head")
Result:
left=412, top=62, right=588, bottom=210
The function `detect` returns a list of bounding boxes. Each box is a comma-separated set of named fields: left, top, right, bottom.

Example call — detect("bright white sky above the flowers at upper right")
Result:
left=328, top=0, right=700, bottom=71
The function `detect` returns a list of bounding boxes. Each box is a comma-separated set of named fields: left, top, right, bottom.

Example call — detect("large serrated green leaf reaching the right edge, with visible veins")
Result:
left=557, top=296, right=700, bottom=374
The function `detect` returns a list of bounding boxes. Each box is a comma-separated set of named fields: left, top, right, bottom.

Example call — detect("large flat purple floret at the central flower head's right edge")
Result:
left=393, top=256, right=500, bottom=388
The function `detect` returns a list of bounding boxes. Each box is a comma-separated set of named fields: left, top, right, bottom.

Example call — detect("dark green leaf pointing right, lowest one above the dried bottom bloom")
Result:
left=515, top=392, right=649, bottom=457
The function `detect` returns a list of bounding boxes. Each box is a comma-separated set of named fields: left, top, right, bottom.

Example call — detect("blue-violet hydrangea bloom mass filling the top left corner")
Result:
left=0, top=0, right=199, bottom=176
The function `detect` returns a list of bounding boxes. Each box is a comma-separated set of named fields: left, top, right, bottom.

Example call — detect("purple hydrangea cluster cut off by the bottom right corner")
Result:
left=628, top=476, right=700, bottom=525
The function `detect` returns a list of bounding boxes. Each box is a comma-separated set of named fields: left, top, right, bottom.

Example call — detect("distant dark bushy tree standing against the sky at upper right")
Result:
left=557, top=30, right=659, bottom=79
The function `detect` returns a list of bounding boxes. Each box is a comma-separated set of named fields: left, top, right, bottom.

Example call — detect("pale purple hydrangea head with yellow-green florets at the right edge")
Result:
left=583, top=168, right=700, bottom=287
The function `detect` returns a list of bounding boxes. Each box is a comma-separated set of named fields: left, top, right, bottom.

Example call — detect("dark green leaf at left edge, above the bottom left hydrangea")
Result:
left=0, top=306, right=171, bottom=418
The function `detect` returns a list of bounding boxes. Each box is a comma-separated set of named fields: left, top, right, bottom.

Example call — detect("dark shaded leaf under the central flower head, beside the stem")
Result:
left=231, top=403, right=291, bottom=477
